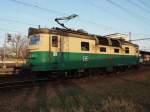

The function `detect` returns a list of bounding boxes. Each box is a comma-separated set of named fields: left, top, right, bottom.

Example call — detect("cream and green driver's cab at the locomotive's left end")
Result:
left=28, top=28, right=61, bottom=71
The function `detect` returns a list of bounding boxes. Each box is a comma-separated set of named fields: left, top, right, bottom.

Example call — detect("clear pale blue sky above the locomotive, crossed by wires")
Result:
left=0, top=0, right=150, bottom=51
